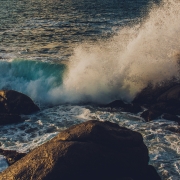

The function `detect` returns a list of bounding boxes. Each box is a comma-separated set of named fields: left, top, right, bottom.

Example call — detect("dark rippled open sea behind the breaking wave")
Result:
left=0, top=0, right=158, bottom=61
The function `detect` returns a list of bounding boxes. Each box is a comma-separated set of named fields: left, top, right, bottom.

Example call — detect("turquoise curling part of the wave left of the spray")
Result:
left=0, top=59, right=66, bottom=103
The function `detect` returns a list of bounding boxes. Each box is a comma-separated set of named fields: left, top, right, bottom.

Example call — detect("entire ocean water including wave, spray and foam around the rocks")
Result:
left=0, top=0, right=180, bottom=180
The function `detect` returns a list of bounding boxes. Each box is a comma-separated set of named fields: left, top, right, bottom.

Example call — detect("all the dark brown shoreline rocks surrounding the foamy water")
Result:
left=0, top=83, right=180, bottom=180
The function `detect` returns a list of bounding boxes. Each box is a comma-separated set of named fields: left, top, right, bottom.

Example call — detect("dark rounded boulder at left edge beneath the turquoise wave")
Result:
left=0, top=90, right=39, bottom=114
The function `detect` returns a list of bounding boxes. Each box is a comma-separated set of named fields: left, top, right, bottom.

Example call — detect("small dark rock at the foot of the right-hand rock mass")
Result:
left=141, top=110, right=162, bottom=122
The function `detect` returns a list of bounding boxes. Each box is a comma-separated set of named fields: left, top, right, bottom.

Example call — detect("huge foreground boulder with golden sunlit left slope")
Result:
left=0, top=121, right=160, bottom=180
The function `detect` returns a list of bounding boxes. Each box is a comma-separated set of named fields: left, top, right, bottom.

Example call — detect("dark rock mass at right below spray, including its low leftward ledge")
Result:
left=105, top=82, right=180, bottom=122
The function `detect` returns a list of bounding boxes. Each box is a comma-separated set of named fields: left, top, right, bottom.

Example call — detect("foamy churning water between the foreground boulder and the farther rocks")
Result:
left=0, top=105, right=180, bottom=180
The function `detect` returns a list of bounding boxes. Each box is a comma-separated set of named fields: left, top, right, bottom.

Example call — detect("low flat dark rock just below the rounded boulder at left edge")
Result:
left=0, top=114, right=23, bottom=125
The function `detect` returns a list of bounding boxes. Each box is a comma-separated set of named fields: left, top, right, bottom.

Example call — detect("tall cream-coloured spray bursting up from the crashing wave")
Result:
left=60, top=0, right=180, bottom=103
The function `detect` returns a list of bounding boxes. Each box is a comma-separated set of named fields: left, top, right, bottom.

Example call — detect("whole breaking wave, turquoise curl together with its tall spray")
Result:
left=0, top=0, right=180, bottom=104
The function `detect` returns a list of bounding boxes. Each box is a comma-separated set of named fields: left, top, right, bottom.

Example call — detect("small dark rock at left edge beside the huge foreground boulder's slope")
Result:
left=0, top=149, right=26, bottom=165
